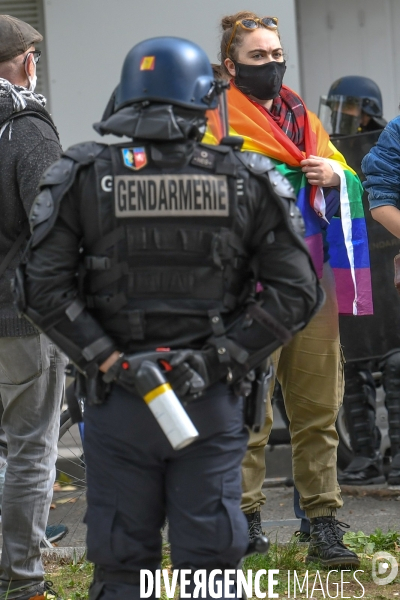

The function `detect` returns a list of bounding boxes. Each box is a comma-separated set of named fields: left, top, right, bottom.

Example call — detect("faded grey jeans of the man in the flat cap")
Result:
left=0, top=333, right=67, bottom=599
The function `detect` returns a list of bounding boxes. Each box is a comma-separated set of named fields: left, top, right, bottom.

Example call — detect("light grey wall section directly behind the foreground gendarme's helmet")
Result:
left=44, top=0, right=300, bottom=148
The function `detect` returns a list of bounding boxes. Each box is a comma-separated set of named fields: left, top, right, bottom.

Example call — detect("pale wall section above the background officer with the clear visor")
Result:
left=297, top=0, right=400, bottom=120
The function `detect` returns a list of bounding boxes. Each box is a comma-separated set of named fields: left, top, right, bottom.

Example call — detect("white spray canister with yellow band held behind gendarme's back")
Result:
left=135, top=360, right=199, bottom=450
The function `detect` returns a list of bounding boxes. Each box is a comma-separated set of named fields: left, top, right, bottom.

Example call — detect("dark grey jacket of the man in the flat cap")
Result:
left=0, top=98, right=61, bottom=337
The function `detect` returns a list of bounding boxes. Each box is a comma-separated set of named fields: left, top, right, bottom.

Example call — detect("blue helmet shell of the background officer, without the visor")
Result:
left=327, top=75, right=383, bottom=117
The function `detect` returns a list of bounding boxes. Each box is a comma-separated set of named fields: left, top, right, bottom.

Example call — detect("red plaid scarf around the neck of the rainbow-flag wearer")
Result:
left=253, top=86, right=306, bottom=151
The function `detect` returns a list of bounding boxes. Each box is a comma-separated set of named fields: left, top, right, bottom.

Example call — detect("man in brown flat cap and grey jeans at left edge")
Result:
left=0, top=15, right=66, bottom=600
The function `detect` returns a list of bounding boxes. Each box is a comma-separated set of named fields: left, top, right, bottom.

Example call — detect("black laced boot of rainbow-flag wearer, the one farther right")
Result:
left=306, top=517, right=360, bottom=568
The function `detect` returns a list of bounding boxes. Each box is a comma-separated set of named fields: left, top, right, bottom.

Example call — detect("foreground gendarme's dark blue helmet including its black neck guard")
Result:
left=104, top=37, right=229, bottom=142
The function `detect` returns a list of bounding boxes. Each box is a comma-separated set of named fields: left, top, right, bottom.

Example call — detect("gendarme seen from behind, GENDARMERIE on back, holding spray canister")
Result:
left=15, top=37, right=321, bottom=600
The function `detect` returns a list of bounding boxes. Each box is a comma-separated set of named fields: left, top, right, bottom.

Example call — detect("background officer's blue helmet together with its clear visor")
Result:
left=319, top=75, right=386, bottom=135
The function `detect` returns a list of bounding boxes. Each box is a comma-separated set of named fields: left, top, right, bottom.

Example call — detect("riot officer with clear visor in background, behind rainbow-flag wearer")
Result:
left=320, top=76, right=400, bottom=485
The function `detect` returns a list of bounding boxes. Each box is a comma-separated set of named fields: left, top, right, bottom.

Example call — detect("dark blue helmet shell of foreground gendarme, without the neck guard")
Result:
left=115, top=37, right=218, bottom=111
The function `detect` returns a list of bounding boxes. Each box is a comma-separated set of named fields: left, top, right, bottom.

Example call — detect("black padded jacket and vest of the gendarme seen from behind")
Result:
left=21, top=103, right=318, bottom=376
